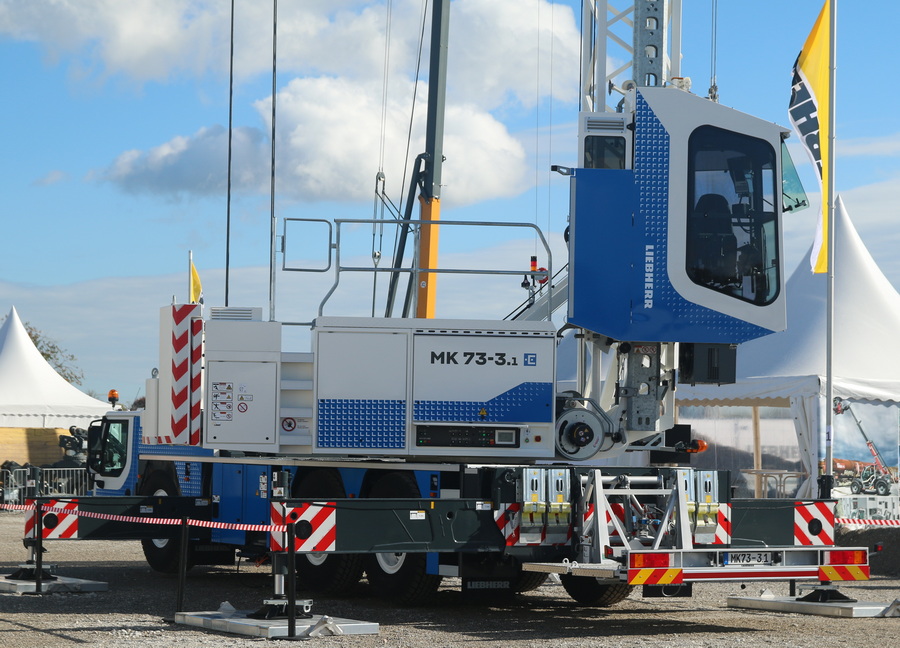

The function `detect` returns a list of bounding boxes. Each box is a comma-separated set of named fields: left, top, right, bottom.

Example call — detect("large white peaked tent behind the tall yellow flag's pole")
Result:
left=676, top=198, right=900, bottom=497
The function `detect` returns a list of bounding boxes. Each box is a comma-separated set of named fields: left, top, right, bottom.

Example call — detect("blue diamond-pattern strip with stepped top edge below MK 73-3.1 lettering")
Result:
left=413, top=382, right=553, bottom=423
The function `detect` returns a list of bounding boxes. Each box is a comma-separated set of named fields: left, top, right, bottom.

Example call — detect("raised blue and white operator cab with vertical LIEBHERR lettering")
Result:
left=564, top=87, right=793, bottom=344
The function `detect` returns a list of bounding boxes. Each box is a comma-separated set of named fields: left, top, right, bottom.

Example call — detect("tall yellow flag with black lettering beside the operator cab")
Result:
left=788, top=0, right=832, bottom=272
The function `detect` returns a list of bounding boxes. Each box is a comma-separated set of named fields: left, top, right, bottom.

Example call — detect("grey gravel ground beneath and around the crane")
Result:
left=0, top=511, right=900, bottom=648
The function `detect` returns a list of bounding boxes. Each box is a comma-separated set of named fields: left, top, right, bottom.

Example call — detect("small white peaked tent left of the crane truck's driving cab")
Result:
left=0, top=307, right=110, bottom=429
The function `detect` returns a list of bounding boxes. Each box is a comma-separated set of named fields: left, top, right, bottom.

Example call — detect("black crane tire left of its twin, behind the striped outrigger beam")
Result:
left=292, top=470, right=363, bottom=596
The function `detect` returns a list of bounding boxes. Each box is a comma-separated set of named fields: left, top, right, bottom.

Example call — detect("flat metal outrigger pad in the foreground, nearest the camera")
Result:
left=175, top=609, right=378, bottom=639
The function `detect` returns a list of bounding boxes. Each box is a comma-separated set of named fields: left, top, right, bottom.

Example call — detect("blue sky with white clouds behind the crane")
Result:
left=0, top=0, right=900, bottom=402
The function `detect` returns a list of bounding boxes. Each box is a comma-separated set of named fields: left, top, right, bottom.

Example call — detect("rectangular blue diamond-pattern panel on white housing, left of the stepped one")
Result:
left=318, top=398, right=406, bottom=450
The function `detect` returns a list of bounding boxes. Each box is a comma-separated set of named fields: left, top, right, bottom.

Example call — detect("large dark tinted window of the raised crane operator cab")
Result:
left=686, top=126, right=781, bottom=305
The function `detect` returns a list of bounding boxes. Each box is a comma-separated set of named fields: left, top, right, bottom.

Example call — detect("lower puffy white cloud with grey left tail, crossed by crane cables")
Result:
left=96, top=77, right=529, bottom=205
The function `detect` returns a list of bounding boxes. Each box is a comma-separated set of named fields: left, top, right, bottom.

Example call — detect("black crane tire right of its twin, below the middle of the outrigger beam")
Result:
left=365, top=473, right=441, bottom=605
